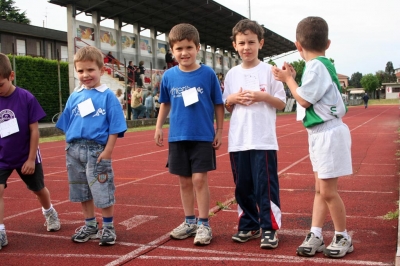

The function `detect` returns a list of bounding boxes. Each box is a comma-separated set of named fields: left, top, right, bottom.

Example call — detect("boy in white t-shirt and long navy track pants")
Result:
left=223, top=19, right=286, bottom=249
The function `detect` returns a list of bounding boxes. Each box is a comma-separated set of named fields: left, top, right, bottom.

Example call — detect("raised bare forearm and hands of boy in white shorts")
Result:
left=272, top=62, right=311, bottom=108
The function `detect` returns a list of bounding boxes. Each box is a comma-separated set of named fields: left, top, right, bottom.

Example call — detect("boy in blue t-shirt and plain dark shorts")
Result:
left=154, top=23, right=224, bottom=245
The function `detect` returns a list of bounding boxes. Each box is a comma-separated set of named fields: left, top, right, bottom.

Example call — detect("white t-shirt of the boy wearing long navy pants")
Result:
left=222, top=62, right=286, bottom=152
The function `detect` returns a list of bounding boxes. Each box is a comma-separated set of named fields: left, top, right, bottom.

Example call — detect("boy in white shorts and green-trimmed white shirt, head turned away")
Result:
left=273, top=17, right=354, bottom=258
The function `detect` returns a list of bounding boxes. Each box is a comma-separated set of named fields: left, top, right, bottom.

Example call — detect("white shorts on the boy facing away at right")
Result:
left=307, top=119, right=353, bottom=179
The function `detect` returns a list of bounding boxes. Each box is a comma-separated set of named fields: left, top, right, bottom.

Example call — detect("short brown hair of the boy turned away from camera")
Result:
left=296, top=17, right=329, bottom=52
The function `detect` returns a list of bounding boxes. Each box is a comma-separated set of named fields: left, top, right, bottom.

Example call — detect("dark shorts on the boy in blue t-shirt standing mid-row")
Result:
left=167, top=141, right=217, bottom=177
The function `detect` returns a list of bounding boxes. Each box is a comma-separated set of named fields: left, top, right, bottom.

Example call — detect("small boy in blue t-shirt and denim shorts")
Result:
left=56, top=46, right=127, bottom=245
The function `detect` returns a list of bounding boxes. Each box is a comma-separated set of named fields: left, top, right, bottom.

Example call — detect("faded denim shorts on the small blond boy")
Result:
left=65, top=139, right=115, bottom=208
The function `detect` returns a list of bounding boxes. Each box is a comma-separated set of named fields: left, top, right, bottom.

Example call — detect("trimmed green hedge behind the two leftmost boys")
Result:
left=8, top=55, right=69, bottom=122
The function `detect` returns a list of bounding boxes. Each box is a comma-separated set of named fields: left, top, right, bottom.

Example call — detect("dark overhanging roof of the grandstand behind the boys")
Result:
left=48, top=0, right=296, bottom=58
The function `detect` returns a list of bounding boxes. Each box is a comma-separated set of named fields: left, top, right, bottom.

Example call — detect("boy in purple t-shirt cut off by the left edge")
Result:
left=0, top=54, right=60, bottom=249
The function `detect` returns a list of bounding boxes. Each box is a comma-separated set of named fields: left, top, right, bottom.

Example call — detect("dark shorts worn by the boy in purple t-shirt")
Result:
left=0, top=163, right=44, bottom=191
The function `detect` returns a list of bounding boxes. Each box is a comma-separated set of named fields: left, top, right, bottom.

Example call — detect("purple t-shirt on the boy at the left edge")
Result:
left=0, top=87, right=46, bottom=169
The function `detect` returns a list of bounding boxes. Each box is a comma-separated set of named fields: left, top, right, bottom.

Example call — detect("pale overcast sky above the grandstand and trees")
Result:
left=14, top=0, right=400, bottom=78
